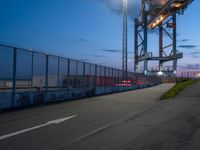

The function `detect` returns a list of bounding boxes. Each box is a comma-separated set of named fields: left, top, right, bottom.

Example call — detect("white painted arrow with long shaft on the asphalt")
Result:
left=0, top=115, right=77, bottom=140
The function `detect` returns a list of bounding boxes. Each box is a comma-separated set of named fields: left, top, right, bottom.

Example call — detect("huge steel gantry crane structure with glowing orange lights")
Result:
left=134, top=0, right=193, bottom=75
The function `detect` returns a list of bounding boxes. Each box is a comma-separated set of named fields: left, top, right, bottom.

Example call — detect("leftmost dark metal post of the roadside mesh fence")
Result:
left=11, top=48, right=17, bottom=107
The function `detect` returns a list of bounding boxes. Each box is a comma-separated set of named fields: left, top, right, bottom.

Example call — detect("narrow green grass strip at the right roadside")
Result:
left=160, top=79, right=198, bottom=100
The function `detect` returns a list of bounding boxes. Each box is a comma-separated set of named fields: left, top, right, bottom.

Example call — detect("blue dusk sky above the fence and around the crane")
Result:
left=0, top=0, right=200, bottom=71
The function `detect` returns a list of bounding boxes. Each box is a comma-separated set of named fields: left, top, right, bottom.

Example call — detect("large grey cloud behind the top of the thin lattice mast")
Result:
left=97, top=0, right=140, bottom=19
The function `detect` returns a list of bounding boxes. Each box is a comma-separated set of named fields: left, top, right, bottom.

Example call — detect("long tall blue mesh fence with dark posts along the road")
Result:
left=0, top=45, right=160, bottom=109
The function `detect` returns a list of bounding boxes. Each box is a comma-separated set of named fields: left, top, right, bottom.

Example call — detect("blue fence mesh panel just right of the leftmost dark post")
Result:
left=13, top=49, right=33, bottom=107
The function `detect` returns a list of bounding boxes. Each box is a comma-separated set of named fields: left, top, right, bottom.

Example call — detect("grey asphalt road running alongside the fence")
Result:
left=0, top=83, right=200, bottom=150
